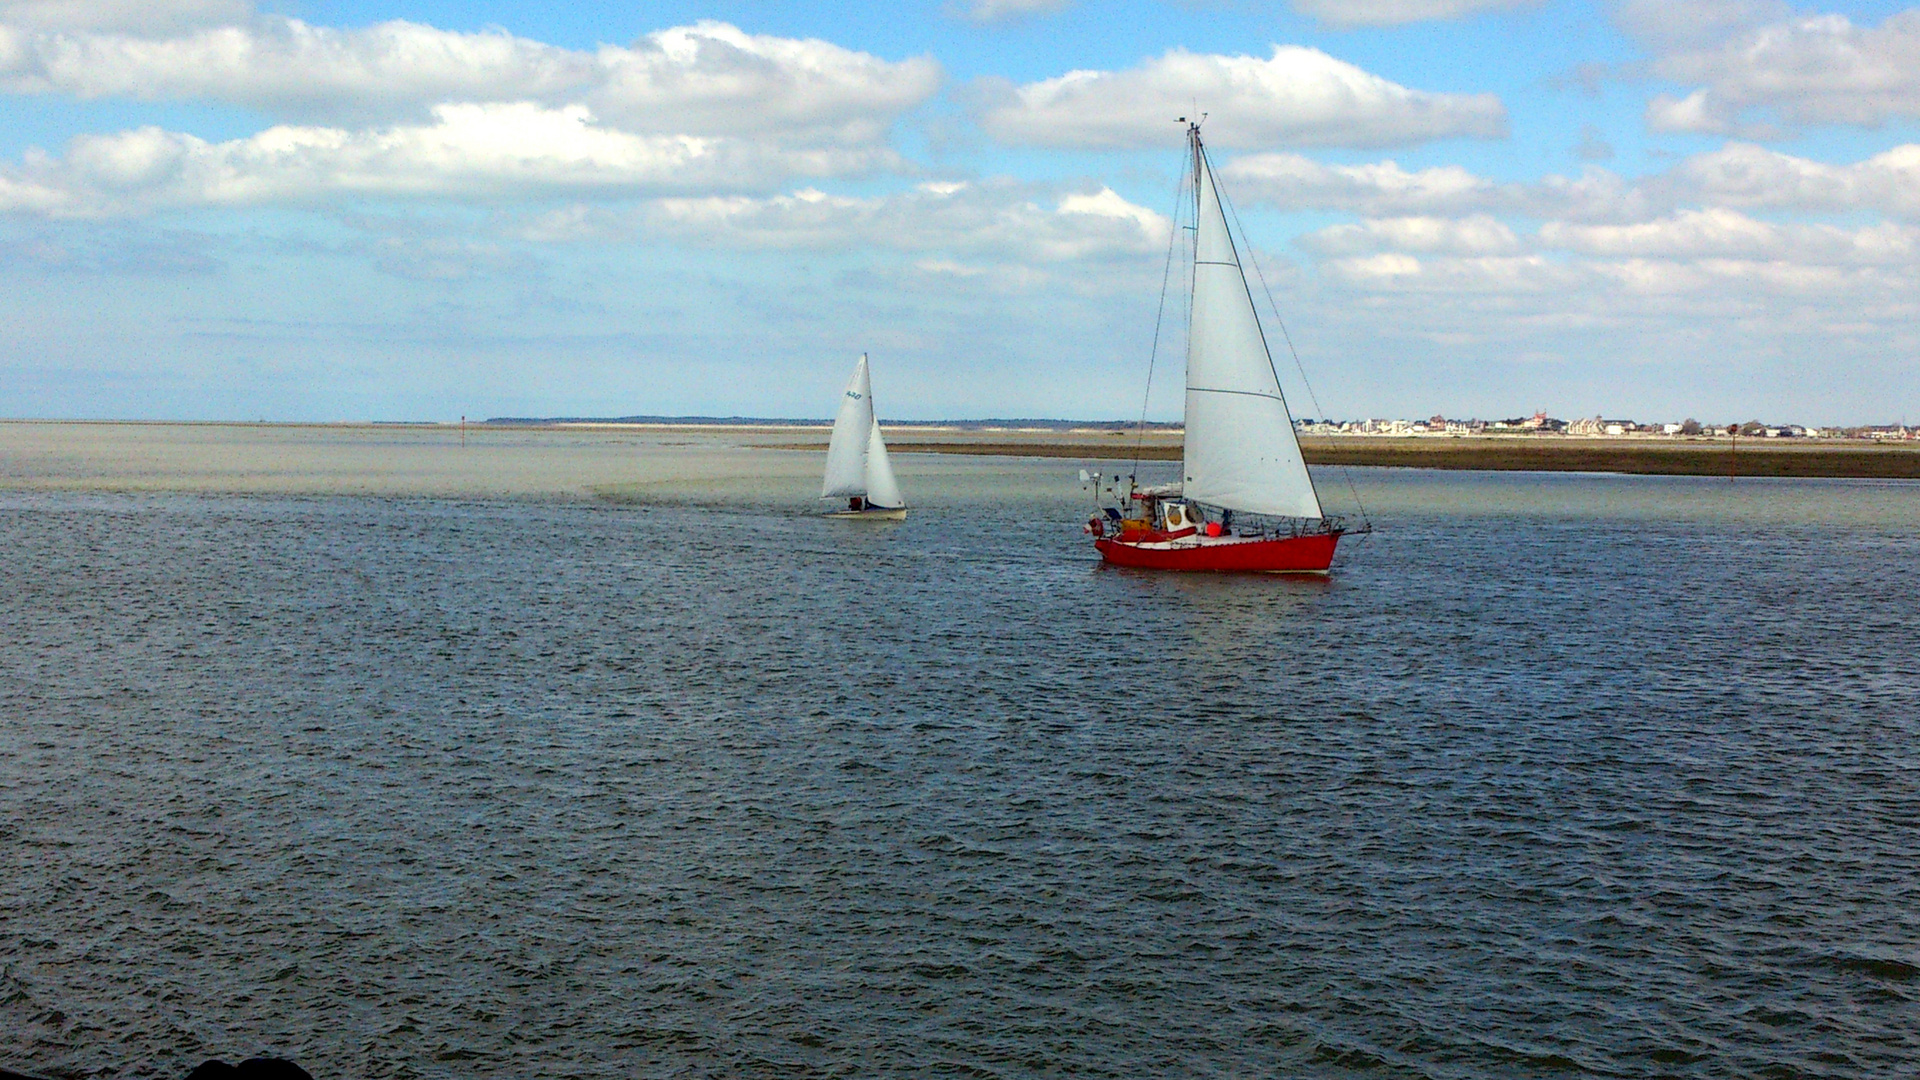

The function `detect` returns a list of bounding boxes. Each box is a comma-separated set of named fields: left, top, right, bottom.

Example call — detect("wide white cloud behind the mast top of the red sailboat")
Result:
left=981, top=46, right=1507, bottom=150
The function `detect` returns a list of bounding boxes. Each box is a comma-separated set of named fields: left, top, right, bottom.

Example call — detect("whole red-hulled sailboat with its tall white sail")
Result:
left=1087, top=123, right=1352, bottom=575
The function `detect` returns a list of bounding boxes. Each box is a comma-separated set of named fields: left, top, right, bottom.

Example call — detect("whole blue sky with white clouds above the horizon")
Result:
left=0, top=0, right=1920, bottom=425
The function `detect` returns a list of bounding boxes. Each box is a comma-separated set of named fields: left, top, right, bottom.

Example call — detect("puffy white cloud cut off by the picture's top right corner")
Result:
left=1647, top=6, right=1920, bottom=136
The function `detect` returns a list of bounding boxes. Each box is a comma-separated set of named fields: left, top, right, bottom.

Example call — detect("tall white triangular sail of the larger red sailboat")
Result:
left=1183, top=142, right=1321, bottom=517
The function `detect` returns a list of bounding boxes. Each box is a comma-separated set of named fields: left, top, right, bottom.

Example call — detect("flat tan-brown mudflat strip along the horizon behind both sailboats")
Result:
left=15, top=421, right=1920, bottom=488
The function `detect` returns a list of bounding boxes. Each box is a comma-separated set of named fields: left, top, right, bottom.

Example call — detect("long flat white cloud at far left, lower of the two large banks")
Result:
left=0, top=102, right=893, bottom=217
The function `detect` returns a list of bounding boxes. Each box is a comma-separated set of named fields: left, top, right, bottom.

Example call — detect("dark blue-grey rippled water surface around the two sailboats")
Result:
left=0, top=461, right=1920, bottom=1080
